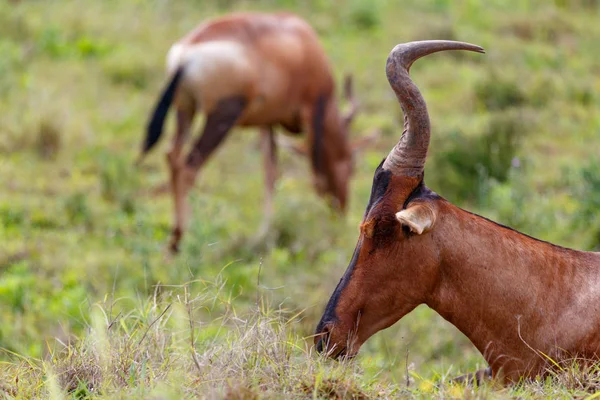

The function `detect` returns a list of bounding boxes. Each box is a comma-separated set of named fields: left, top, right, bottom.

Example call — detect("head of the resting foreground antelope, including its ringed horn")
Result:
left=315, top=40, right=483, bottom=356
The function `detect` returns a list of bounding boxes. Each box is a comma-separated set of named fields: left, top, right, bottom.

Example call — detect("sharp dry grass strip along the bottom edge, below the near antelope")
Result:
left=0, top=282, right=600, bottom=399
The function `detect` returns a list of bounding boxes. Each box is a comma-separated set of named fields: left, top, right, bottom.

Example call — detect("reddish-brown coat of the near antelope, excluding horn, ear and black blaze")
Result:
left=318, top=177, right=600, bottom=381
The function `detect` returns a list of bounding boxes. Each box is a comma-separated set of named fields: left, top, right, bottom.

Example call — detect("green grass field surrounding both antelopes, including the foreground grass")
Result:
left=0, top=0, right=600, bottom=399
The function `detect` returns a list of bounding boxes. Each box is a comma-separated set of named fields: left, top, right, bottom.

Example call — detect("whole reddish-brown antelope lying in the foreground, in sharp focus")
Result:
left=315, top=41, right=600, bottom=382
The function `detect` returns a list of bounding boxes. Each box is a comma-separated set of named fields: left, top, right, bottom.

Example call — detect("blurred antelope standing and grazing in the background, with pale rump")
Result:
left=140, top=13, right=364, bottom=251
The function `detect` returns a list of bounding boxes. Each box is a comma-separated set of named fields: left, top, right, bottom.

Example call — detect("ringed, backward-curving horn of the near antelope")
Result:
left=383, top=40, right=485, bottom=177
